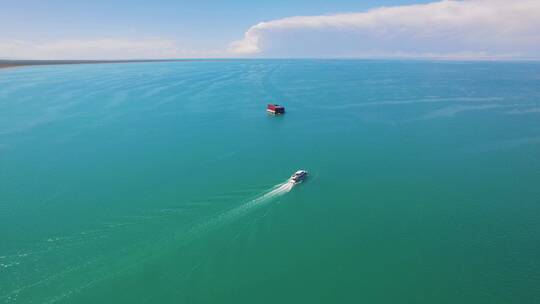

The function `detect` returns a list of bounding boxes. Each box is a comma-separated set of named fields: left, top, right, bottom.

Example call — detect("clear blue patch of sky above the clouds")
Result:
left=0, top=0, right=428, bottom=48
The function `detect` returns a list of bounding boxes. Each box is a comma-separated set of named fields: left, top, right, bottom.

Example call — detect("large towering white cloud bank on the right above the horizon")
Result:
left=229, top=0, right=540, bottom=59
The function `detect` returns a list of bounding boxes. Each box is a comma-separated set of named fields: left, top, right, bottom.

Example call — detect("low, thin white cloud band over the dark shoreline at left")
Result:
left=0, top=38, right=219, bottom=60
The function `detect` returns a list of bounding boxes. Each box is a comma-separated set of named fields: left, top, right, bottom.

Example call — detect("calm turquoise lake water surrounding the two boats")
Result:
left=0, top=60, right=540, bottom=304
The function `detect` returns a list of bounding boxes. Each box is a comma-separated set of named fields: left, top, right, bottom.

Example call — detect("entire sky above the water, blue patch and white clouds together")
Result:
left=0, top=0, right=540, bottom=59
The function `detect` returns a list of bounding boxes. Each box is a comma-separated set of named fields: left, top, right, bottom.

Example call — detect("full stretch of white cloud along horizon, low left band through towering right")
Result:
left=5, top=0, right=540, bottom=59
